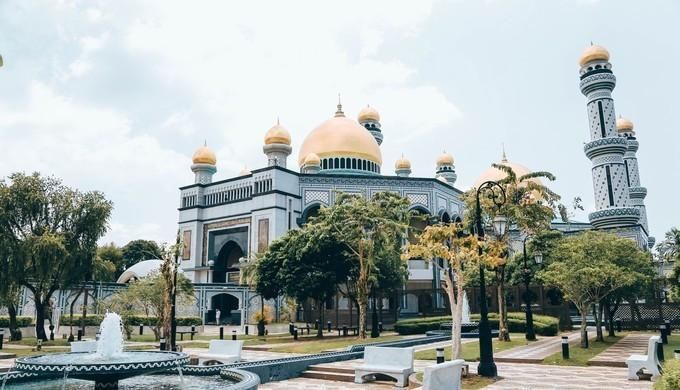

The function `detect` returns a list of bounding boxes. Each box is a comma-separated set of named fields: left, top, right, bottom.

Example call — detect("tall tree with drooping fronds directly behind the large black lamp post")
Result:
left=464, top=163, right=560, bottom=341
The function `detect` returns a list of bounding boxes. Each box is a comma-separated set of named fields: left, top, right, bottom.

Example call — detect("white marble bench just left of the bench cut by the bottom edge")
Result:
left=354, top=347, right=413, bottom=387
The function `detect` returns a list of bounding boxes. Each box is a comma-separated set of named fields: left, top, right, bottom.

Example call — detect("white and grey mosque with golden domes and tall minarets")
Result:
left=179, top=45, right=654, bottom=323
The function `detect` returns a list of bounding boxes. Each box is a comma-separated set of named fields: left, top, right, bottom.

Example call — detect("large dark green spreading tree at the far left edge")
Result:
left=0, top=173, right=112, bottom=340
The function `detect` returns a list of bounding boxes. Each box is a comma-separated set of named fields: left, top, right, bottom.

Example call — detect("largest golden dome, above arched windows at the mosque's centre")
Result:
left=298, top=109, right=382, bottom=166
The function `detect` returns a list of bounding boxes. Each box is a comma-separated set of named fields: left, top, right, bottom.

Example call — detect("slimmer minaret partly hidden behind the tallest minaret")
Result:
left=616, top=116, right=655, bottom=244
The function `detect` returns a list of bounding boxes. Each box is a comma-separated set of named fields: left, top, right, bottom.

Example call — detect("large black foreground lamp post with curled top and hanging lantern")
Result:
left=474, top=181, right=508, bottom=378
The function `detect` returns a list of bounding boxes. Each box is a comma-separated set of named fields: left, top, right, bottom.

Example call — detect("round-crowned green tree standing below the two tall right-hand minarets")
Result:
left=538, top=231, right=649, bottom=348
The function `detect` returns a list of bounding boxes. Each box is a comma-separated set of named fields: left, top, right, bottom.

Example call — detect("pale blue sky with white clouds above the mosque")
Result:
left=0, top=0, right=680, bottom=245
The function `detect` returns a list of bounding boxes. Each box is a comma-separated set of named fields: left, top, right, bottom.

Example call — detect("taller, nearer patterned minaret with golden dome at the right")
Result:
left=579, top=45, right=640, bottom=228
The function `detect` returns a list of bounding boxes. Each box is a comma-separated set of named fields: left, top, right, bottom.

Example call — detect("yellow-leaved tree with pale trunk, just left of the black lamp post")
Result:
left=403, top=224, right=503, bottom=359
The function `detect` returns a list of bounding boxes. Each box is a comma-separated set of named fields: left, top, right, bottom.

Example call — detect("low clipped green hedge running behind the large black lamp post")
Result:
left=394, top=312, right=560, bottom=336
